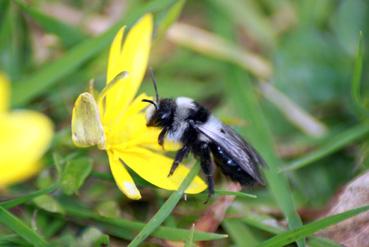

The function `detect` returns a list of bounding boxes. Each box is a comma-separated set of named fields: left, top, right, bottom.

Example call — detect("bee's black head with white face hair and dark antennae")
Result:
left=142, top=68, right=175, bottom=127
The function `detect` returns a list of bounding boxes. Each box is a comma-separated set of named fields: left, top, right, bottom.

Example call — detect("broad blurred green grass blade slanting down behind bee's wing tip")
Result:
left=229, top=68, right=304, bottom=246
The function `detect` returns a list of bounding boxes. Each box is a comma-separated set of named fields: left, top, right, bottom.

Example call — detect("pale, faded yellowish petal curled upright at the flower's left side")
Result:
left=72, top=93, right=105, bottom=148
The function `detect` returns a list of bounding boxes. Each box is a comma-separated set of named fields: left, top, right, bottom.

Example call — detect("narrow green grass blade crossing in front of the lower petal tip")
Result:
left=128, top=163, right=200, bottom=247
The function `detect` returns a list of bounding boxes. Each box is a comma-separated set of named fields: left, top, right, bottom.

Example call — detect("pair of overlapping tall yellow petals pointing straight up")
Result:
left=103, top=14, right=153, bottom=122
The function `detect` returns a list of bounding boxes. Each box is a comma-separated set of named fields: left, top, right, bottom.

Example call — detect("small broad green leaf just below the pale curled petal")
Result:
left=60, top=157, right=92, bottom=195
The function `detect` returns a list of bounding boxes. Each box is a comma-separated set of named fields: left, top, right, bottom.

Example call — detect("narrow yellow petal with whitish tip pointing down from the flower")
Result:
left=108, top=151, right=141, bottom=200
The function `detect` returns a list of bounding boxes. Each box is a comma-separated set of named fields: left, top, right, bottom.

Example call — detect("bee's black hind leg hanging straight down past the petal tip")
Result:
left=198, top=143, right=214, bottom=204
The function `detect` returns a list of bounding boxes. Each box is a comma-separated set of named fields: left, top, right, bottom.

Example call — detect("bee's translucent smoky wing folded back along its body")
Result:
left=195, top=117, right=265, bottom=184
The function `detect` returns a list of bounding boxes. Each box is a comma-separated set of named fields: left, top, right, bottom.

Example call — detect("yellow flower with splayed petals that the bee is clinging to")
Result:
left=72, top=14, right=206, bottom=200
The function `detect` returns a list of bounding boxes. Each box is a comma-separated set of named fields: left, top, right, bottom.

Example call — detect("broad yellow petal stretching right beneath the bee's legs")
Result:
left=119, top=147, right=207, bottom=194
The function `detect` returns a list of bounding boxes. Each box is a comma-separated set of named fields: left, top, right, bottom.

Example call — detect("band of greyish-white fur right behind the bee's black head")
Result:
left=167, top=97, right=196, bottom=142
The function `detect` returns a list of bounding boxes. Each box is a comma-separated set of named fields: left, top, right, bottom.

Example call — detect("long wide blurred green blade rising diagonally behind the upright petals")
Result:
left=11, top=0, right=176, bottom=106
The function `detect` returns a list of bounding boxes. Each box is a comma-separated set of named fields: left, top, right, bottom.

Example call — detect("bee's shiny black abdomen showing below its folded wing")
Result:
left=210, top=143, right=257, bottom=185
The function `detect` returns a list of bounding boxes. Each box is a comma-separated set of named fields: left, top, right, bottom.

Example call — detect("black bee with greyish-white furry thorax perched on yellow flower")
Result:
left=142, top=70, right=265, bottom=199
